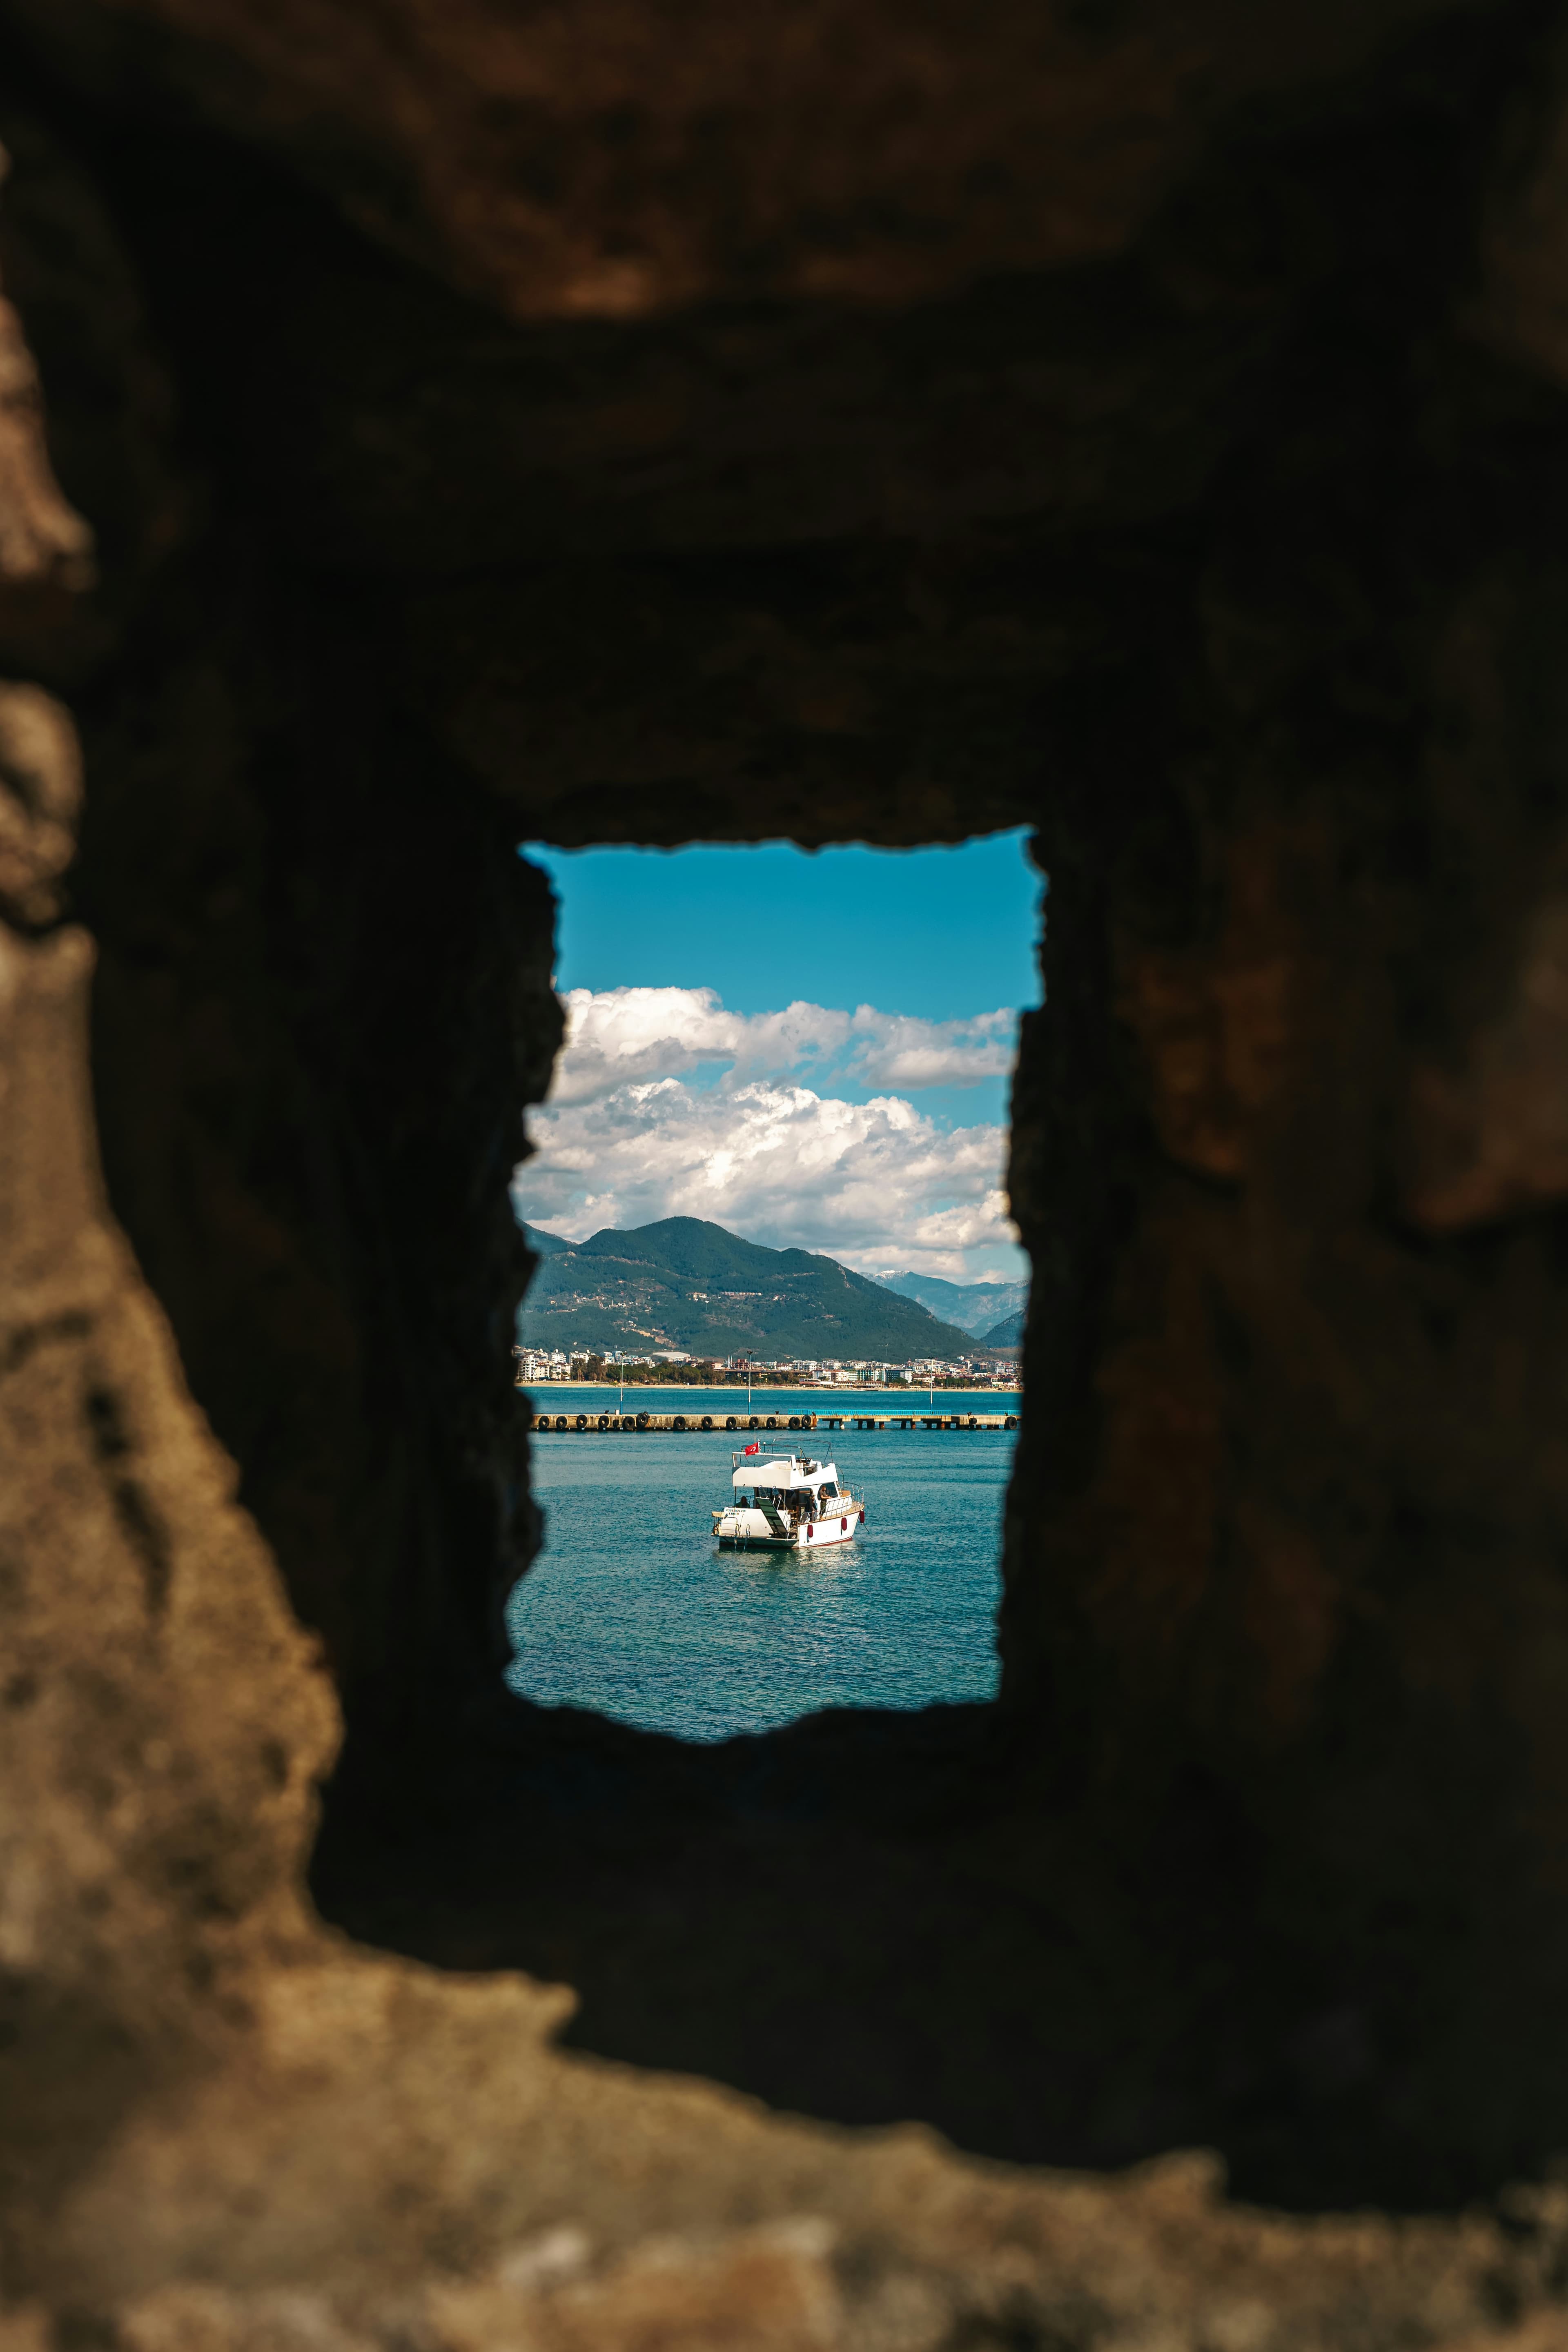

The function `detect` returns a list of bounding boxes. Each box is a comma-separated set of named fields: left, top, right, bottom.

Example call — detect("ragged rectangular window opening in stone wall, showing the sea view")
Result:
left=508, top=835, right=1041, bottom=1740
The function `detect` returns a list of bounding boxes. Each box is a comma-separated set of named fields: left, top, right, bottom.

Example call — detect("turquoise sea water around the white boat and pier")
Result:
left=508, top=1385, right=1018, bottom=1740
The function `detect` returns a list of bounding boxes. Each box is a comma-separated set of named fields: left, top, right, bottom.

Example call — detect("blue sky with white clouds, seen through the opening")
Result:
left=515, top=833, right=1041, bottom=1279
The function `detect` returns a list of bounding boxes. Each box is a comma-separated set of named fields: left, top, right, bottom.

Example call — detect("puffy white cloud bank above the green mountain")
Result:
left=515, top=988, right=1016, bottom=1279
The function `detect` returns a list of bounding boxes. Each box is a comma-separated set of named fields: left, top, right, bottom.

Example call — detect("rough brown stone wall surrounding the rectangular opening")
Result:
left=0, top=0, right=1568, bottom=2352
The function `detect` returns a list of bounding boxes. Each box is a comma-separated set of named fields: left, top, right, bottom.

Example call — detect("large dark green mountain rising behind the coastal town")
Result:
left=517, top=1216, right=976, bottom=1364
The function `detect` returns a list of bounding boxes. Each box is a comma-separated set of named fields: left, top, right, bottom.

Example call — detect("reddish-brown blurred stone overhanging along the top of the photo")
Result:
left=7, top=0, right=1486, bottom=320
